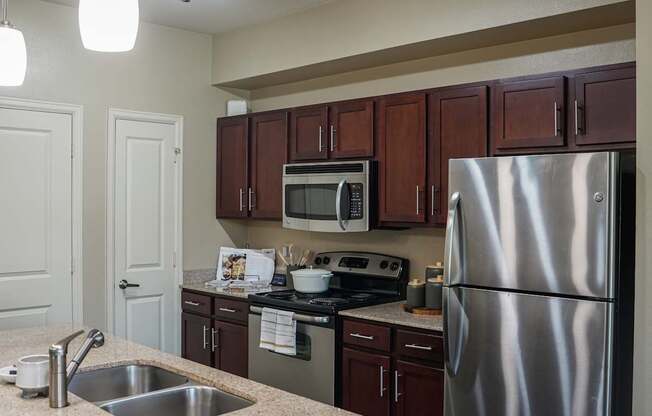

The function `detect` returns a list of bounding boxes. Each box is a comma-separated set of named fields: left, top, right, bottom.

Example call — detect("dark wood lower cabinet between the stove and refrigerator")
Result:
left=341, top=319, right=444, bottom=416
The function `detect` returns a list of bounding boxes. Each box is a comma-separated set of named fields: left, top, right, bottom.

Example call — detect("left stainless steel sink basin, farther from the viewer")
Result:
left=69, top=365, right=188, bottom=402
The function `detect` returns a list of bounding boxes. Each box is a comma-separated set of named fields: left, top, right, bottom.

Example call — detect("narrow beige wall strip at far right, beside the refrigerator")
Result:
left=632, top=0, right=652, bottom=415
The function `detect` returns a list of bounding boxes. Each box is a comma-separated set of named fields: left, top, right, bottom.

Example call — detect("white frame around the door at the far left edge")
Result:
left=0, top=96, right=84, bottom=325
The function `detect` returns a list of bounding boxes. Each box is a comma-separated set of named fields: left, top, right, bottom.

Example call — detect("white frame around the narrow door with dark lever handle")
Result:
left=106, top=108, right=183, bottom=352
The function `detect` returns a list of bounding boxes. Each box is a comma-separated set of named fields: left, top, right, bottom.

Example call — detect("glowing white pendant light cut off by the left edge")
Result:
left=0, top=0, right=27, bottom=87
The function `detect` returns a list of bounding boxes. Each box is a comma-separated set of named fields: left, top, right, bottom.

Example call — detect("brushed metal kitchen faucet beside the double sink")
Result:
left=49, top=329, right=104, bottom=408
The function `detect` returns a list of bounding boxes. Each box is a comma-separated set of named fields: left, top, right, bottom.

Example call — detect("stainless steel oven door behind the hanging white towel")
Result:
left=249, top=306, right=335, bottom=405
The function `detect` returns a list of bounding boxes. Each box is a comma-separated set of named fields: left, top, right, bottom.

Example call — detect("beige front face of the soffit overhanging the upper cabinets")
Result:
left=212, top=0, right=621, bottom=84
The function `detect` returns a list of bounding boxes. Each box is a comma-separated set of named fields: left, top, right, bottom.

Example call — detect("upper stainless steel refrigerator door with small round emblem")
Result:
left=445, top=153, right=618, bottom=298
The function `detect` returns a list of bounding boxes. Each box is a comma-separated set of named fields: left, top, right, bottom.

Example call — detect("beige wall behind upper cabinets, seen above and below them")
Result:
left=242, top=24, right=635, bottom=277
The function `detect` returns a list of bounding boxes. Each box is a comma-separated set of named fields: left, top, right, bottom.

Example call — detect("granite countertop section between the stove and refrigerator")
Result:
left=339, top=302, right=443, bottom=332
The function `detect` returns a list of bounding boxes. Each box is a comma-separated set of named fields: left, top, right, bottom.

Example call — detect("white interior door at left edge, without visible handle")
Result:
left=0, top=108, right=73, bottom=330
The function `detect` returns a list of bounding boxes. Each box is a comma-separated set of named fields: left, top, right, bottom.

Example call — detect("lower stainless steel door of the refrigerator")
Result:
left=444, top=287, right=613, bottom=416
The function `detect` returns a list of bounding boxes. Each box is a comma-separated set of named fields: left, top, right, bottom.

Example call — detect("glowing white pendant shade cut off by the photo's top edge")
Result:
left=79, top=0, right=139, bottom=52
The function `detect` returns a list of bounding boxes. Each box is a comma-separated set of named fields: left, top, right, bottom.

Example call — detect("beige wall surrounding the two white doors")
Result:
left=0, top=0, right=246, bottom=328
